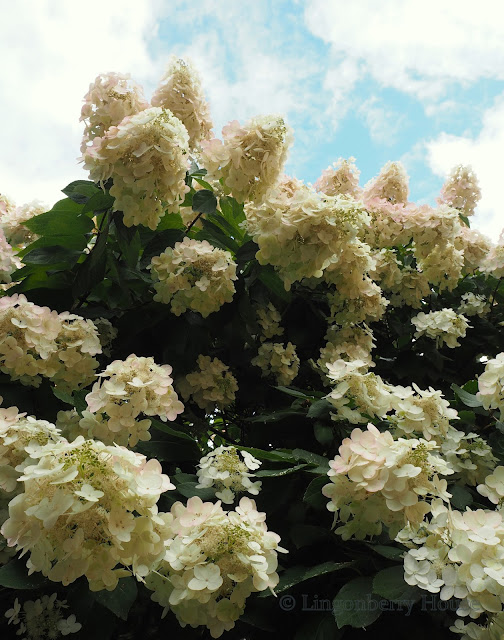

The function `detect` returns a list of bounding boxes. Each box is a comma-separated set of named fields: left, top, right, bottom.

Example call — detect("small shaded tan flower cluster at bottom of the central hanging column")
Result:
left=317, top=325, right=375, bottom=383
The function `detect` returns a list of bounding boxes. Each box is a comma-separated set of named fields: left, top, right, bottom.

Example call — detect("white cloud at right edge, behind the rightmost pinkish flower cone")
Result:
left=426, top=94, right=504, bottom=240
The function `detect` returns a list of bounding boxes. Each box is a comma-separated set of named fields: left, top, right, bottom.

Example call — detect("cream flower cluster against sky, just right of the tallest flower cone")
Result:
left=201, top=115, right=293, bottom=202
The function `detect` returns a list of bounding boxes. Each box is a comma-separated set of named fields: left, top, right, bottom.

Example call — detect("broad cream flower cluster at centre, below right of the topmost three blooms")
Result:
left=245, top=178, right=369, bottom=289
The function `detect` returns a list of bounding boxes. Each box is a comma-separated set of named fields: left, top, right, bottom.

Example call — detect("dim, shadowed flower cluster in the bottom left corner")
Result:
left=5, top=593, right=82, bottom=640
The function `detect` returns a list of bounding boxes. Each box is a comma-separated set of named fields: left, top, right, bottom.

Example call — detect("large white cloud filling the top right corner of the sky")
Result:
left=305, top=0, right=504, bottom=102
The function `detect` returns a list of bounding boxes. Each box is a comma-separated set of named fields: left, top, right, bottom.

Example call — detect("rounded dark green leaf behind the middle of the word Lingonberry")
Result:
left=333, top=578, right=381, bottom=629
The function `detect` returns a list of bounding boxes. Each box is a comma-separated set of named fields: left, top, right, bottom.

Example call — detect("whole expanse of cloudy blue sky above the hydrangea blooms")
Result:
left=0, top=0, right=504, bottom=239
